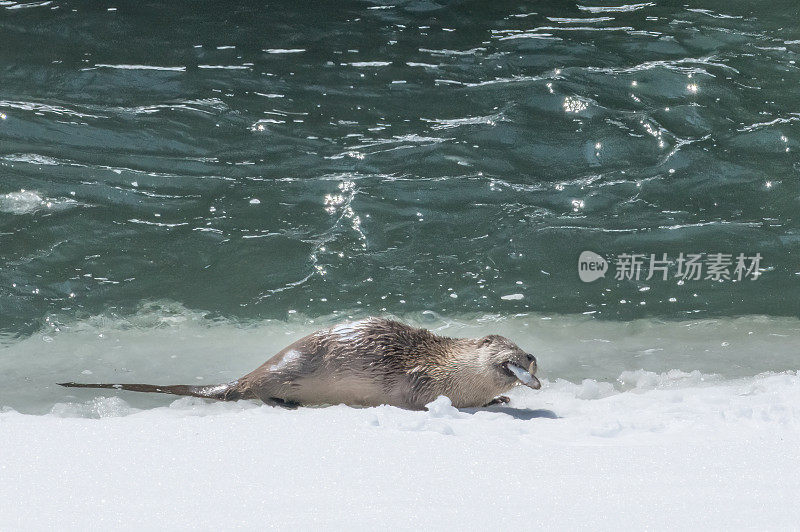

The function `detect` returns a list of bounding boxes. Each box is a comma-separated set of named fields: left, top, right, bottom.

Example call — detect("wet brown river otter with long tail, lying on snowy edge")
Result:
left=59, top=318, right=541, bottom=410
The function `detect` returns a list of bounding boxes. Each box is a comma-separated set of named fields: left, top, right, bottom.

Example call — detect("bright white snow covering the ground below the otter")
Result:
left=0, top=371, right=800, bottom=530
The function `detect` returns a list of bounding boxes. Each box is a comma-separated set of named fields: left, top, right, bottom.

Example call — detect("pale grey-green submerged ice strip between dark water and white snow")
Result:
left=0, top=308, right=800, bottom=414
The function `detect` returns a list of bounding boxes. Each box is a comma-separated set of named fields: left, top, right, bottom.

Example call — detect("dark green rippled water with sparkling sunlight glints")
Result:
left=0, top=0, right=800, bottom=408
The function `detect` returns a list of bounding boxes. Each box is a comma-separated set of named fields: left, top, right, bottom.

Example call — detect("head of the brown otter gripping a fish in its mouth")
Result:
left=475, top=334, right=542, bottom=390
